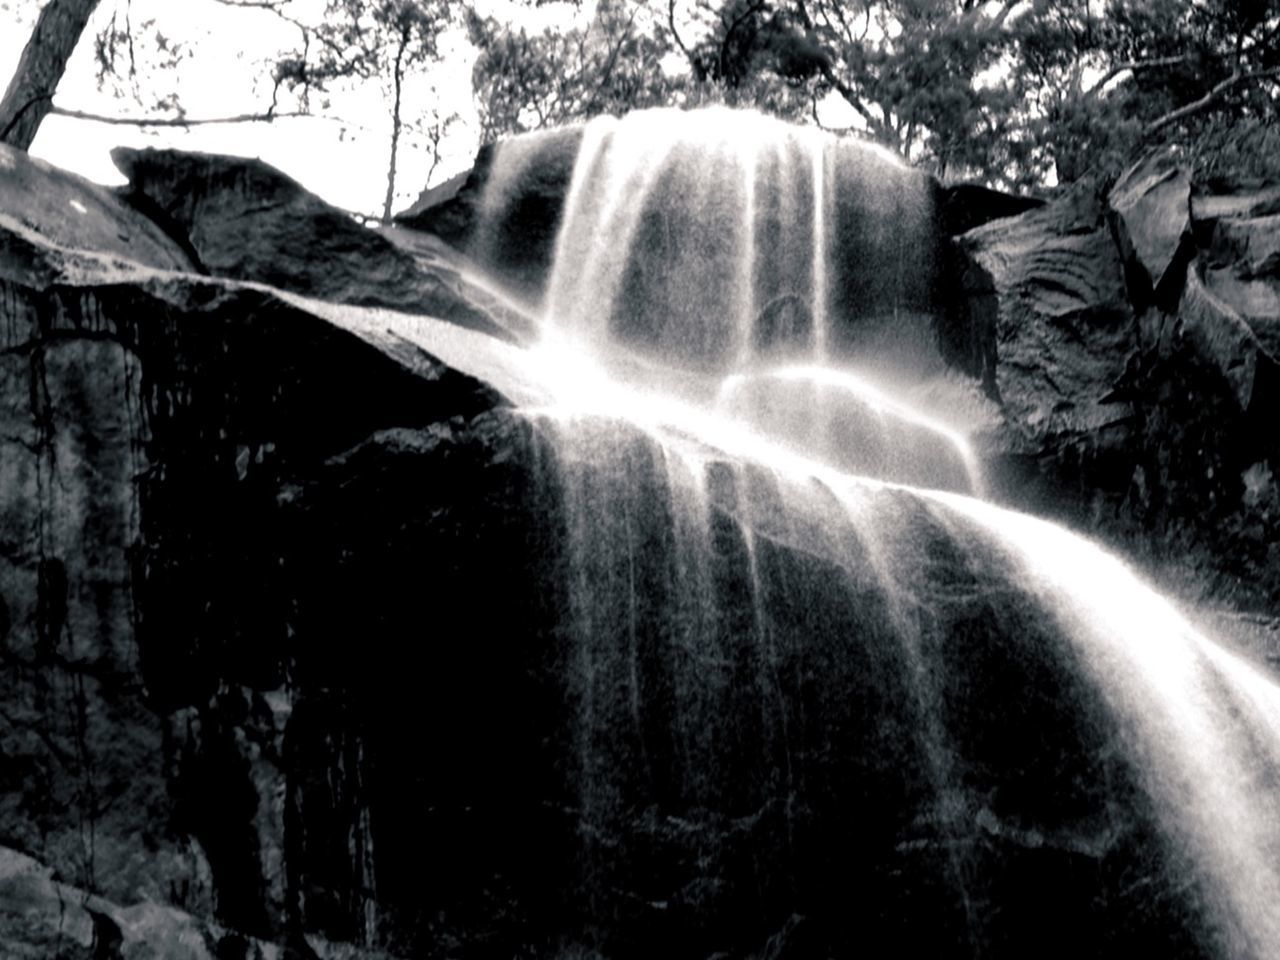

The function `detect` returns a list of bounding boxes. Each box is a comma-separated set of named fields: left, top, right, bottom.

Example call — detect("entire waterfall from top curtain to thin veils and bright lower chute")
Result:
left=471, top=111, right=1280, bottom=959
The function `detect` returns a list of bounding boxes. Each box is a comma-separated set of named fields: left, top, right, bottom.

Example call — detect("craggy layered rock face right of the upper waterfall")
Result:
left=960, top=147, right=1280, bottom=607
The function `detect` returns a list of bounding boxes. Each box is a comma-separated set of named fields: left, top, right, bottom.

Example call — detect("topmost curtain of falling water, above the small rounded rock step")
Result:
left=543, top=108, right=934, bottom=372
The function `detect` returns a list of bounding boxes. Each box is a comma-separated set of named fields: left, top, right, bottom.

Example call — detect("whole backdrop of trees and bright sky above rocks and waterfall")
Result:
left=0, top=0, right=1280, bottom=219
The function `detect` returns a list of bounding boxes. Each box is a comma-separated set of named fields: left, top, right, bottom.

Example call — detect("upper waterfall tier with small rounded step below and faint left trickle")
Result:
left=472, top=108, right=978, bottom=493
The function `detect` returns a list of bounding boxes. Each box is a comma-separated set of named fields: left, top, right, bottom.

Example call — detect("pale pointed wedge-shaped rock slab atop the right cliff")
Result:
left=1110, top=151, right=1193, bottom=310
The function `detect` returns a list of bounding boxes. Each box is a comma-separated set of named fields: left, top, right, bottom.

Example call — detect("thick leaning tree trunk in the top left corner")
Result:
left=0, top=0, right=97, bottom=150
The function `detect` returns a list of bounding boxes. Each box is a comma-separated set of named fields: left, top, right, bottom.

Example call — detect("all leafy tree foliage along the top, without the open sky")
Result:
left=7, top=0, right=1280, bottom=199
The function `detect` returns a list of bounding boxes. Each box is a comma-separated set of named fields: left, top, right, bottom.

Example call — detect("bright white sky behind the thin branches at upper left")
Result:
left=0, top=0, right=586, bottom=215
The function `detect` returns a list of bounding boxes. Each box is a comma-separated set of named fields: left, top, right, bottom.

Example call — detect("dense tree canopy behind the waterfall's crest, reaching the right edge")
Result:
left=471, top=0, right=1280, bottom=187
